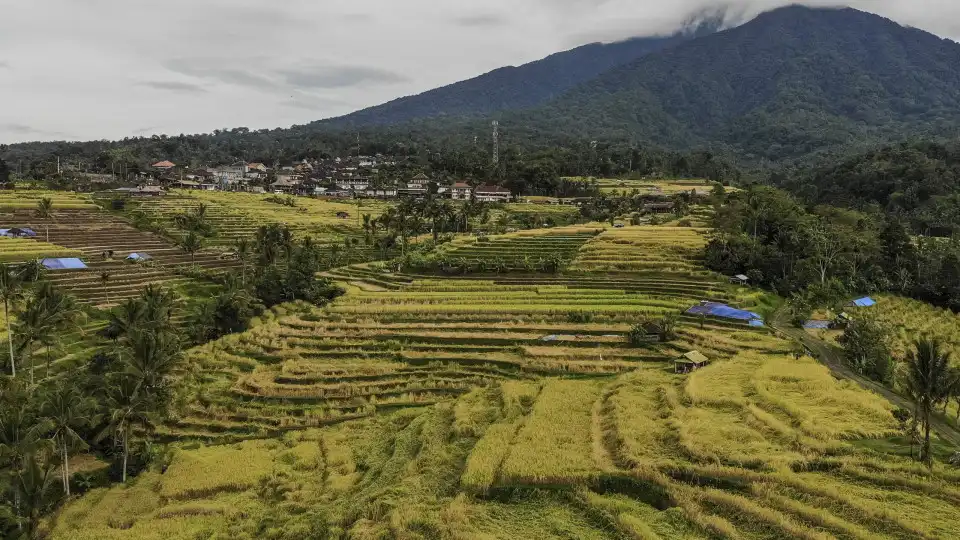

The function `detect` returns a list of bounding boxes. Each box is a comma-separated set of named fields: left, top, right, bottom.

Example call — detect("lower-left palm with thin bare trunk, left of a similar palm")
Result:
left=41, top=381, right=93, bottom=497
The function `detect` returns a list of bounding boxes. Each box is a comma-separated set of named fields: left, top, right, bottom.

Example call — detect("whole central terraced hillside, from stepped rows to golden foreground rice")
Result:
left=49, top=224, right=960, bottom=540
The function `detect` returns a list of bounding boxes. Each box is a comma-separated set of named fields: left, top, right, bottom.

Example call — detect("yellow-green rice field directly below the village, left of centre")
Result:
left=129, top=191, right=388, bottom=244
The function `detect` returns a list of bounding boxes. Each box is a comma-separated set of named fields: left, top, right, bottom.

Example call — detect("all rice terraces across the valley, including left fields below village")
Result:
left=0, top=178, right=960, bottom=540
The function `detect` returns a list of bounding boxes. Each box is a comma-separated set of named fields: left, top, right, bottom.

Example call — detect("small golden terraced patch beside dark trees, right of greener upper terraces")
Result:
left=570, top=226, right=709, bottom=279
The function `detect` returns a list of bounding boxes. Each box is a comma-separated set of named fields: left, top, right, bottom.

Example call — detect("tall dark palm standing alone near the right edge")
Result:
left=905, top=337, right=958, bottom=468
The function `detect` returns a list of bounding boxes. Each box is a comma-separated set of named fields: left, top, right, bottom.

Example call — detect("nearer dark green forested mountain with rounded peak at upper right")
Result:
left=501, top=6, right=960, bottom=160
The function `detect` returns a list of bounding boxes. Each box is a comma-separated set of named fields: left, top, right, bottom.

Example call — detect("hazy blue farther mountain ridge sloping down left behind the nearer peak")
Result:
left=318, top=14, right=723, bottom=127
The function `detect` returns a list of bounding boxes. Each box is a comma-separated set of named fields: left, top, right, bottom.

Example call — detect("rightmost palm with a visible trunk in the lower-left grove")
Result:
left=96, top=375, right=154, bottom=483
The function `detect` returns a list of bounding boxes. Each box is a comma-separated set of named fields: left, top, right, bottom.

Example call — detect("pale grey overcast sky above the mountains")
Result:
left=0, top=0, right=960, bottom=143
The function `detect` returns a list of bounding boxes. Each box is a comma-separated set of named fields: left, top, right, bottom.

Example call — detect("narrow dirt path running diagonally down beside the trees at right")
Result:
left=769, top=310, right=960, bottom=447
